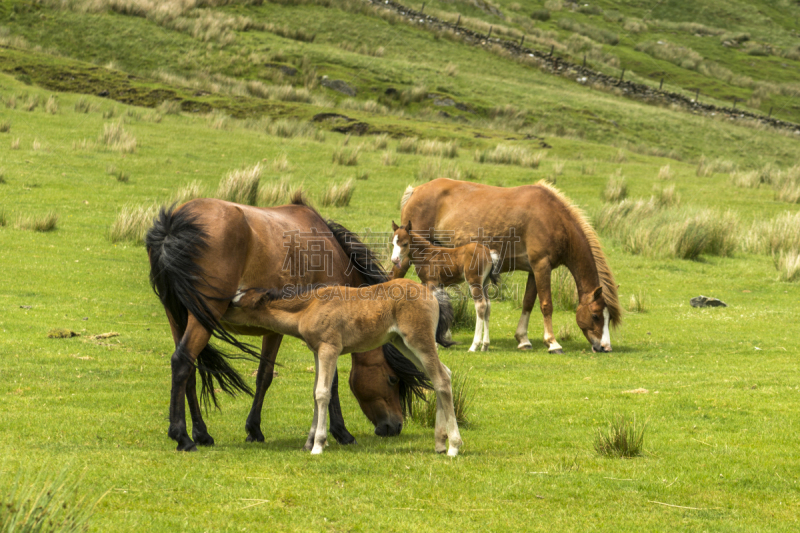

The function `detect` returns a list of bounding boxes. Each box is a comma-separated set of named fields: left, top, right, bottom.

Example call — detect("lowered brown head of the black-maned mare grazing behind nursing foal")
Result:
left=350, top=348, right=403, bottom=437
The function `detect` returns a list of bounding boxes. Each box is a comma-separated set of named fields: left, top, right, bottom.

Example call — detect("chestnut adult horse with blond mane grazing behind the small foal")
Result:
left=392, top=178, right=622, bottom=353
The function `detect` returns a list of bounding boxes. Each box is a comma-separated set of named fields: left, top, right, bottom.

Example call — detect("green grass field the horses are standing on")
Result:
left=0, top=0, right=800, bottom=532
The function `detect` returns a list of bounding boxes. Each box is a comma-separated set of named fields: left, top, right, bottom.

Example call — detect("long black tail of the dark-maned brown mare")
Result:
left=145, top=205, right=260, bottom=407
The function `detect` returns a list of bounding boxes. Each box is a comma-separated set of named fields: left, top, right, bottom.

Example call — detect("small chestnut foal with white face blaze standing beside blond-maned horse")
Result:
left=392, top=220, right=500, bottom=352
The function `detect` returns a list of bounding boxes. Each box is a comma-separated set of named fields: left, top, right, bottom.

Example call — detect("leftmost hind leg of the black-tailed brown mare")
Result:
left=167, top=315, right=211, bottom=451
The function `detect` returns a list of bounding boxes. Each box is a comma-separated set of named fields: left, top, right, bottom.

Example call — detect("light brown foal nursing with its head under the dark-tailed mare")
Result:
left=225, top=279, right=461, bottom=457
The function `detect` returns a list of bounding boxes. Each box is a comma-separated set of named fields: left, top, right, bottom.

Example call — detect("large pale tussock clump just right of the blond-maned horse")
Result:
left=594, top=197, right=739, bottom=259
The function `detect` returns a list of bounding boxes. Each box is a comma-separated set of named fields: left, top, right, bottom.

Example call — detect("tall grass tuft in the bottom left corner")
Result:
left=0, top=468, right=107, bottom=533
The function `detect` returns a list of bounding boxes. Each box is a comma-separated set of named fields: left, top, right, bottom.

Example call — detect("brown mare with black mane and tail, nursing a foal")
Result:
left=147, top=196, right=428, bottom=451
